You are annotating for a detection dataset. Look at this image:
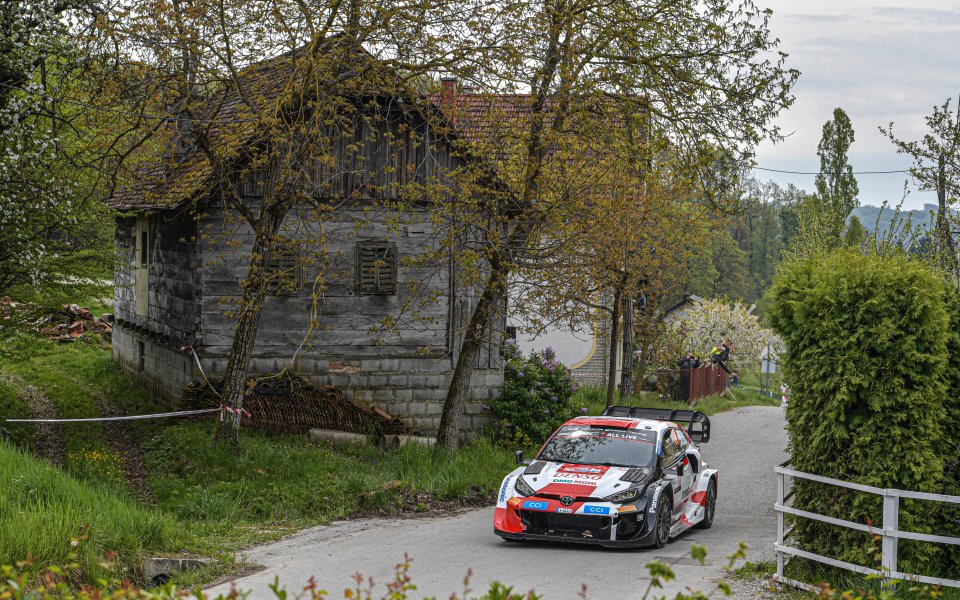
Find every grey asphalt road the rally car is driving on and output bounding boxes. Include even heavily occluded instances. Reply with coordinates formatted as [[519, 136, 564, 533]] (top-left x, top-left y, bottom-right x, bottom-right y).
[[209, 406, 787, 600]]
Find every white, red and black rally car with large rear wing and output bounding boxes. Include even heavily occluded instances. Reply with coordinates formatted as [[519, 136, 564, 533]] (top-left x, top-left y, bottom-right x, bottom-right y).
[[493, 406, 717, 548]]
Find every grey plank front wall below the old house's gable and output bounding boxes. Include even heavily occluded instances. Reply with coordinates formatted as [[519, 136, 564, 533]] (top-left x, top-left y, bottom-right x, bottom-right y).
[[197, 207, 503, 432]]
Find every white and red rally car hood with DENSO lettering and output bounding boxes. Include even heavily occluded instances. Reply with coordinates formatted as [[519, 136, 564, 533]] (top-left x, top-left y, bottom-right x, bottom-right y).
[[523, 461, 653, 500]]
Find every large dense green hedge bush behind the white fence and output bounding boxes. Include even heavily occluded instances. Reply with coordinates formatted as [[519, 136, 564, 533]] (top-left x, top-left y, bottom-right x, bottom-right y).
[[769, 250, 950, 572]]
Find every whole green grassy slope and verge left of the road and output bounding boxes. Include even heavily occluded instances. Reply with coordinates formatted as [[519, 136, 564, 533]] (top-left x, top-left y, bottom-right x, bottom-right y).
[[0, 330, 514, 583]]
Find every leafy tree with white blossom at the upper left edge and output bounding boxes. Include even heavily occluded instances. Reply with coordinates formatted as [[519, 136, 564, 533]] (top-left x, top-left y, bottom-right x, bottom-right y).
[[0, 0, 109, 299]]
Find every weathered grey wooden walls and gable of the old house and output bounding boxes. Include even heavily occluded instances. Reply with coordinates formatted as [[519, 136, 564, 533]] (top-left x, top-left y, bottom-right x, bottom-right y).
[[114, 103, 503, 432]]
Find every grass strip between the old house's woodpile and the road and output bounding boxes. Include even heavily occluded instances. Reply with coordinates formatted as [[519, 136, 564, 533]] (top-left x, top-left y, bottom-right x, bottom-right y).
[[144, 424, 513, 526]]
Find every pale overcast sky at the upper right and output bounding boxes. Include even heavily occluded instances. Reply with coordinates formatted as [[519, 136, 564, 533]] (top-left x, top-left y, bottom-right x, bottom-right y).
[[754, 0, 960, 208]]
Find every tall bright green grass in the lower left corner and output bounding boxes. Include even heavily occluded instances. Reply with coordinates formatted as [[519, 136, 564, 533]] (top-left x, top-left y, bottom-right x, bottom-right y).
[[0, 442, 182, 581]]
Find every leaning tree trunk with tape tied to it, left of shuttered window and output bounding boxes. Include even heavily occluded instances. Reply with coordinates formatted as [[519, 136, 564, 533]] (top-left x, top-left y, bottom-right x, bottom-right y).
[[216, 211, 285, 448]]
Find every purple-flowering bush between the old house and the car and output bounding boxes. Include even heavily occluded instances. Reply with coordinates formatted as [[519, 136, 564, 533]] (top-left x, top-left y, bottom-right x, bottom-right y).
[[487, 346, 578, 446]]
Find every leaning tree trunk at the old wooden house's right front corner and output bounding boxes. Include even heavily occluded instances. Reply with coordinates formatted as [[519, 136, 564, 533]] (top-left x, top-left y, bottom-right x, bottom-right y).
[[437, 263, 509, 450]]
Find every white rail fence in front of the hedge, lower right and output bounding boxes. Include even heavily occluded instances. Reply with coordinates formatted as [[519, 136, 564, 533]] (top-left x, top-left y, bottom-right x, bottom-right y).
[[774, 463, 960, 591]]
